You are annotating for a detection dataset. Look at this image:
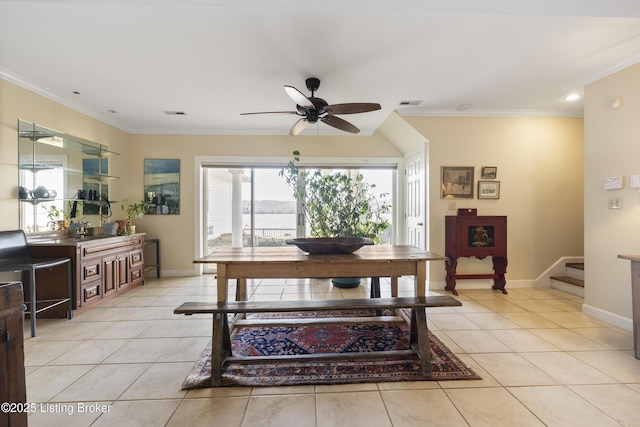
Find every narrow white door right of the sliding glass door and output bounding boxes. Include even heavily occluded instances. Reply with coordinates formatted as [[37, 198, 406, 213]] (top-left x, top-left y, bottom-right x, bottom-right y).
[[405, 151, 427, 249]]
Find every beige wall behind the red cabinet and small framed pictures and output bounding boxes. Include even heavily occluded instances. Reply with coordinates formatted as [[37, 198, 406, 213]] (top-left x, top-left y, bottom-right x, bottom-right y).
[[405, 117, 583, 287]]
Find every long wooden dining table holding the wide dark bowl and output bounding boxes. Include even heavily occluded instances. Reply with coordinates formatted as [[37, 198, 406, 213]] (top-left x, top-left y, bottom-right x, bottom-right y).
[[194, 245, 445, 302]]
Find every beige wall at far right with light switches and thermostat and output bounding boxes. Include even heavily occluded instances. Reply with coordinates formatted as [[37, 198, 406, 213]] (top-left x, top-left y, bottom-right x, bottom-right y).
[[584, 64, 640, 325]]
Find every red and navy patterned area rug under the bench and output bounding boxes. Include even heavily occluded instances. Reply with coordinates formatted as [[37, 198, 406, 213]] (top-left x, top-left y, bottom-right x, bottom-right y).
[[182, 313, 480, 390]]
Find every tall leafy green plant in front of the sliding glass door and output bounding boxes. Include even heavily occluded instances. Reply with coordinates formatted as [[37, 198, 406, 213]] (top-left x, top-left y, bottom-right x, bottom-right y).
[[280, 150, 390, 242]]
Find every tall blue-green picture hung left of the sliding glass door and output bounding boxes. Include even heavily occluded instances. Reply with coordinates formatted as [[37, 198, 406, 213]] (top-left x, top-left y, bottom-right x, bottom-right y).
[[144, 159, 180, 215]]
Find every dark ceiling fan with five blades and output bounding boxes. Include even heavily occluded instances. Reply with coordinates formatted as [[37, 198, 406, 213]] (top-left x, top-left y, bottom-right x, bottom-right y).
[[241, 77, 380, 136]]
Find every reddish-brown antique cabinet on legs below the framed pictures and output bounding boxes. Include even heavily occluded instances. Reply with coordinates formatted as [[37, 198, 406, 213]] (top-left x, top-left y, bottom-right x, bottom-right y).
[[445, 216, 507, 295]]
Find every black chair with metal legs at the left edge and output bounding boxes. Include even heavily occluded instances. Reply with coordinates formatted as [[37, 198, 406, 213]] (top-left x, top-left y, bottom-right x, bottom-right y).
[[0, 230, 73, 337]]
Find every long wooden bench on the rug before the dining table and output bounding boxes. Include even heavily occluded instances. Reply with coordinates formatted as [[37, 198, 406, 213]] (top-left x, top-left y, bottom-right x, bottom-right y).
[[174, 295, 462, 387]]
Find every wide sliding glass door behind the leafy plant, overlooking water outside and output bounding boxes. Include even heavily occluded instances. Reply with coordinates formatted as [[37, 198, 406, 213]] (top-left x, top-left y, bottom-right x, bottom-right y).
[[202, 165, 395, 260]]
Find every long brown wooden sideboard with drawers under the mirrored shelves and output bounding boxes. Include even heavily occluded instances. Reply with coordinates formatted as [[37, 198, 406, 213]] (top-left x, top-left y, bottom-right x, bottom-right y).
[[29, 234, 144, 310]]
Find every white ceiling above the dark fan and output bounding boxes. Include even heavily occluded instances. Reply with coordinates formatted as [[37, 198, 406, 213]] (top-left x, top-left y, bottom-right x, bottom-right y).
[[0, 0, 640, 135]]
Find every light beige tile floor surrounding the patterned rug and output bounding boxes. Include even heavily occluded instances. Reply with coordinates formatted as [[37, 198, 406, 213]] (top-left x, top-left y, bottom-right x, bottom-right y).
[[25, 276, 640, 427]]
